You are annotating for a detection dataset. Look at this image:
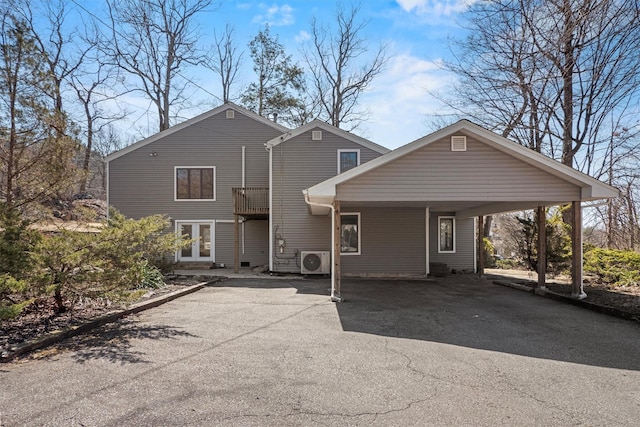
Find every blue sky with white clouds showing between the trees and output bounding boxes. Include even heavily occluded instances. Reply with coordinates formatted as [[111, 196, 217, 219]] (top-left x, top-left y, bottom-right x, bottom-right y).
[[69, 0, 474, 148]]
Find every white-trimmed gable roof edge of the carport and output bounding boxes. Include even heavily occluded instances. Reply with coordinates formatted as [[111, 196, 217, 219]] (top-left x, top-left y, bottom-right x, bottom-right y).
[[303, 120, 619, 211]]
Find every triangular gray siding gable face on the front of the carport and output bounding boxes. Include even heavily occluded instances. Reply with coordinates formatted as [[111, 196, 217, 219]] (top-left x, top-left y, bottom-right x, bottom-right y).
[[337, 136, 580, 202]]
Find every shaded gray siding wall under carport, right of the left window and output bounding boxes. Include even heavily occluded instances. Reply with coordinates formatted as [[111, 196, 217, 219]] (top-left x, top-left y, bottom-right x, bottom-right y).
[[340, 207, 426, 274]]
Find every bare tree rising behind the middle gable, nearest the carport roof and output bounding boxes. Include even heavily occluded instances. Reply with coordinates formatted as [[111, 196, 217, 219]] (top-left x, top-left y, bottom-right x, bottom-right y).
[[303, 2, 387, 130]]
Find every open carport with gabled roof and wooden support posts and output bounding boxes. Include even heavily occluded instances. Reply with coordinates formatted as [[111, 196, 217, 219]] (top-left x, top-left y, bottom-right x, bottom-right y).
[[303, 120, 619, 301]]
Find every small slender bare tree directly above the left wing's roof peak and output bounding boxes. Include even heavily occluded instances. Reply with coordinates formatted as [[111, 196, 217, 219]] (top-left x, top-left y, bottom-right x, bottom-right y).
[[205, 25, 242, 103]]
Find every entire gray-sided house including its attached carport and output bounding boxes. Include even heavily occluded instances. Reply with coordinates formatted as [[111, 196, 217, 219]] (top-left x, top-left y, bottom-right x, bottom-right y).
[[107, 103, 618, 298]]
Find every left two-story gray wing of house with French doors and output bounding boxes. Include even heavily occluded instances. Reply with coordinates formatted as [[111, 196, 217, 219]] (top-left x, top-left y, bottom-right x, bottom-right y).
[[107, 104, 288, 266]]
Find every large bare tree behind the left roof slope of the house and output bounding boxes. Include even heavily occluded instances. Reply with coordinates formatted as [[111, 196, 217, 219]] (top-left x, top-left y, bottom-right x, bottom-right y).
[[102, 0, 212, 131]]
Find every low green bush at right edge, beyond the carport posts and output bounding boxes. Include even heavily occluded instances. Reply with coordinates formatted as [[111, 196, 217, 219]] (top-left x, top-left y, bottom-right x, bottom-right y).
[[584, 248, 640, 286]]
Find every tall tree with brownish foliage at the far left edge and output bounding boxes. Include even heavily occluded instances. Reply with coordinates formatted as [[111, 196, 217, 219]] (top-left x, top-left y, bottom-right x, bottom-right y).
[[0, 9, 77, 207]]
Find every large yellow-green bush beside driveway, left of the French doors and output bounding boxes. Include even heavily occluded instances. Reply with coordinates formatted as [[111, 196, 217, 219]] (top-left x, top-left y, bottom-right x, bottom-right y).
[[35, 210, 190, 312]]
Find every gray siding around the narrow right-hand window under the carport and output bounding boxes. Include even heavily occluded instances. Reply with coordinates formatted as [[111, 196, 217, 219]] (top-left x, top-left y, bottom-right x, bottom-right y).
[[429, 212, 476, 271]]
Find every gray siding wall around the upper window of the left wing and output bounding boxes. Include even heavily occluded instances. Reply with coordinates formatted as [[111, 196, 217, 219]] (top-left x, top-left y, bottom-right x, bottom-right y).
[[109, 111, 281, 220]]
